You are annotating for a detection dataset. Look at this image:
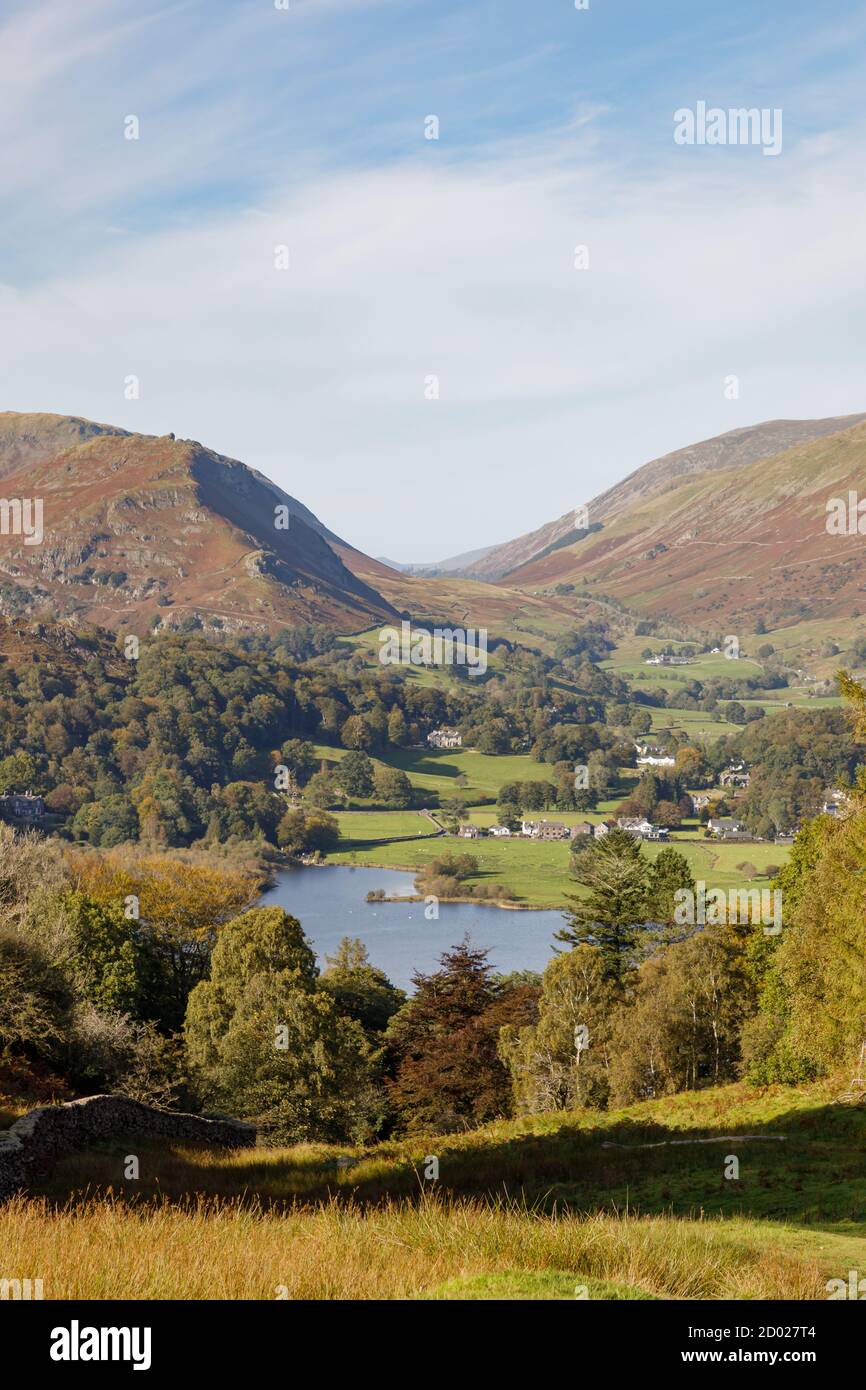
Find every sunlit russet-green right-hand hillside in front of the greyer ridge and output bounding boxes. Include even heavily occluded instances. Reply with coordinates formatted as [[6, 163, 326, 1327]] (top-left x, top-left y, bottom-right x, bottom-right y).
[[505, 416, 866, 632]]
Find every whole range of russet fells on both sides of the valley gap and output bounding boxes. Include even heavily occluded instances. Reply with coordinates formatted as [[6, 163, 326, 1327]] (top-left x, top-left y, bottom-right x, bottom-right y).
[[0, 413, 866, 648]]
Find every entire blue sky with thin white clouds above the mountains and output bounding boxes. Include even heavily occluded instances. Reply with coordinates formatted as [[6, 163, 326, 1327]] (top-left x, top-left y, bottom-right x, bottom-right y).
[[0, 0, 866, 560]]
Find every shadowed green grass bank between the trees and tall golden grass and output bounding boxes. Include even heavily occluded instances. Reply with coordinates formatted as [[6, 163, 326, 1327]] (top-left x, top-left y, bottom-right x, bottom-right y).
[[27, 1080, 866, 1226]]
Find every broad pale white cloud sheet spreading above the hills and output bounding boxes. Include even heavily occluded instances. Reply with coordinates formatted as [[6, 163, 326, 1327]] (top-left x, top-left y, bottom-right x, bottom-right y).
[[0, 0, 866, 560]]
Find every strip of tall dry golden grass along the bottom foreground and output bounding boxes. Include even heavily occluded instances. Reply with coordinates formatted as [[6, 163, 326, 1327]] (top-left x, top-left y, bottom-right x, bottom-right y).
[[0, 1195, 826, 1300]]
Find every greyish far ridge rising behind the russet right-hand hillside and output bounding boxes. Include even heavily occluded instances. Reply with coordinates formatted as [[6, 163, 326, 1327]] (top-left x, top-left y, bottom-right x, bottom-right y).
[[460, 414, 866, 581]]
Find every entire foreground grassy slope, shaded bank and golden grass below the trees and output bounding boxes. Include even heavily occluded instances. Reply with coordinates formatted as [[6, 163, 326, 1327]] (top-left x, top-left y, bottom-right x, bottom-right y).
[[8, 1077, 866, 1300]]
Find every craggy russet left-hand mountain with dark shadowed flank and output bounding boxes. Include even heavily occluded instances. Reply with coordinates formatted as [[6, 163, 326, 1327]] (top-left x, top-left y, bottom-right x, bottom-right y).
[[0, 413, 396, 632]]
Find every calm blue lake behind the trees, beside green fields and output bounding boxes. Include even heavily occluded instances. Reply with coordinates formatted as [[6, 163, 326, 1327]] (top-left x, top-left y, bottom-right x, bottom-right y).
[[261, 865, 563, 990]]
